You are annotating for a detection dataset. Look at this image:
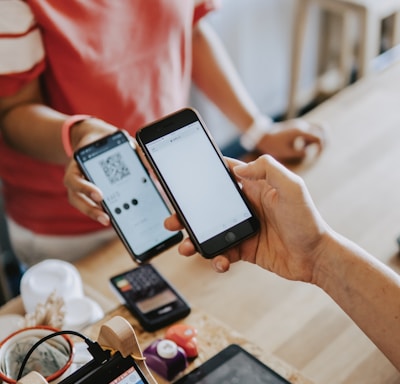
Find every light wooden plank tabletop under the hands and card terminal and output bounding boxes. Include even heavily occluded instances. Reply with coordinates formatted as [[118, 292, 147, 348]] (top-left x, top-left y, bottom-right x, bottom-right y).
[[2, 64, 400, 384]]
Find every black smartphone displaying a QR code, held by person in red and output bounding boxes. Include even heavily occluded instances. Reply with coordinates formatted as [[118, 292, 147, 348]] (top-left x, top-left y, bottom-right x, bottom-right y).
[[74, 131, 183, 263]]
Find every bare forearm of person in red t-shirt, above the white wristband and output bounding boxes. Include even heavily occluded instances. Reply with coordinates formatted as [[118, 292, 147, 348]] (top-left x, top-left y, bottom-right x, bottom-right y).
[[192, 21, 260, 130]]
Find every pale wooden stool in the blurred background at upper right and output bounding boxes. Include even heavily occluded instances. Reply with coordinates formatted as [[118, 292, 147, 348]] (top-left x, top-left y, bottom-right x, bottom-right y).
[[287, 0, 400, 118]]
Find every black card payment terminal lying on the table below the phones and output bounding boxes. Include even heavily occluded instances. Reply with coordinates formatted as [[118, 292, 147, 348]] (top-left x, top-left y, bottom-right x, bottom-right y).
[[110, 264, 190, 332]]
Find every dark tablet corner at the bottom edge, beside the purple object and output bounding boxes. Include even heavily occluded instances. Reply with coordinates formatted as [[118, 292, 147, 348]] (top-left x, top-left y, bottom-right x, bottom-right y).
[[175, 344, 290, 384]]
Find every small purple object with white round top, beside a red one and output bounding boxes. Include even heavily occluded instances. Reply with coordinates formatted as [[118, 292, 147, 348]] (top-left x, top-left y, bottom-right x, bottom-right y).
[[143, 339, 188, 381]]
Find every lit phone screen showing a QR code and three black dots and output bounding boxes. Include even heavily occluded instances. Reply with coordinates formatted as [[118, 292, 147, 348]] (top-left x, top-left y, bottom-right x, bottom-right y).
[[83, 138, 173, 255]]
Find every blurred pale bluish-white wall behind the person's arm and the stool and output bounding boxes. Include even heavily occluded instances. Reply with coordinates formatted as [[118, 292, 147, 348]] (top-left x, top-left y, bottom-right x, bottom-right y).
[[192, 0, 318, 147]]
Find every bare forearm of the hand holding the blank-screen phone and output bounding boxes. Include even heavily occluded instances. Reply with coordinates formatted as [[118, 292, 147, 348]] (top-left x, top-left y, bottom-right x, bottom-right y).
[[314, 234, 400, 369]]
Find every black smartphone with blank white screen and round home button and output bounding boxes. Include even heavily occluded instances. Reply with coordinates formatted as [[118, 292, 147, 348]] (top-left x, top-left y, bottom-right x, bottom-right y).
[[136, 108, 259, 258]]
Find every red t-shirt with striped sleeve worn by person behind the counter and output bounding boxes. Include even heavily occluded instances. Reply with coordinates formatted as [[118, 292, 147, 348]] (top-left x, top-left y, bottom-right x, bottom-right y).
[[0, 0, 219, 235]]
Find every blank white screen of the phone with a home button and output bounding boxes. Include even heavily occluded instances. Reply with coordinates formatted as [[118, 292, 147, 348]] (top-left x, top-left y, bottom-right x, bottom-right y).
[[146, 122, 252, 243]]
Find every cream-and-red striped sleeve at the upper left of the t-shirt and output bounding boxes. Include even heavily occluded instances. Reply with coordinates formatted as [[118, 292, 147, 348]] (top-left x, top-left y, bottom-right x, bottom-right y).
[[0, 0, 45, 97]]
